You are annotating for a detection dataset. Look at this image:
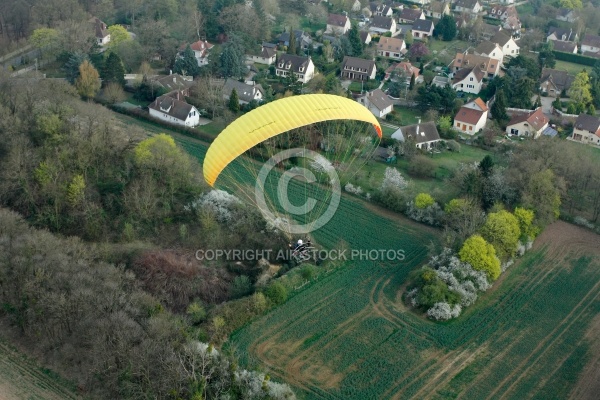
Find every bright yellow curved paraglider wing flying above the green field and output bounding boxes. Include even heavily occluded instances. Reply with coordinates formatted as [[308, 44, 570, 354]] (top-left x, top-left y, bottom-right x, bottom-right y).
[[203, 94, 381, 186]]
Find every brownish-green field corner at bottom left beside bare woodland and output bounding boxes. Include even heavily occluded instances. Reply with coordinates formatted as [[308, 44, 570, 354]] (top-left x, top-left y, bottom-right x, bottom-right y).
[[0, 338, 79, 400]]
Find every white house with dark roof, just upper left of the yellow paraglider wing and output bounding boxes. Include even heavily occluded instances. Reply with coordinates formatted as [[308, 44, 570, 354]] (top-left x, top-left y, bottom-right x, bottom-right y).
[[148, 91, 200, 127]]
